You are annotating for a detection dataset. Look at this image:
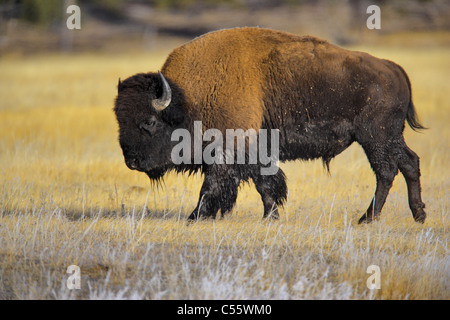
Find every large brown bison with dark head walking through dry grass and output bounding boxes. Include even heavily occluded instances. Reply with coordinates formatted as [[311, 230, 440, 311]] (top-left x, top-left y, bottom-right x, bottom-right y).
[[114, 28, 426, 223]]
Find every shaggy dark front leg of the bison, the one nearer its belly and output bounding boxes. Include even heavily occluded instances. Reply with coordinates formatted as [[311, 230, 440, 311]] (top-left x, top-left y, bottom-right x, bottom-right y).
[[251, 167, 287, 219]]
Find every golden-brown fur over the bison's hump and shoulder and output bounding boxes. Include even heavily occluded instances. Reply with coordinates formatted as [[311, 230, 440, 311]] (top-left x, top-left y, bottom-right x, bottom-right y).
[[162, 28, 320, 130]]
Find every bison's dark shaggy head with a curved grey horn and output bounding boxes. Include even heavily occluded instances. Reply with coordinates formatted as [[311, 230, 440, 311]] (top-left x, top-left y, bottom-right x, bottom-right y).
[[114, 72, 184, 179]]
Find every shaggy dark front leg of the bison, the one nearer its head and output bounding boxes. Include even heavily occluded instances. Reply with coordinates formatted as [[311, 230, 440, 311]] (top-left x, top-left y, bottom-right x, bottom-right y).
[[188, 165, 240, 220]]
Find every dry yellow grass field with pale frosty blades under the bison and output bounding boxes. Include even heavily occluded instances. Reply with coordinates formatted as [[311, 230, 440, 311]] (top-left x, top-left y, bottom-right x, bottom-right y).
[[0, 41, 450, 299]]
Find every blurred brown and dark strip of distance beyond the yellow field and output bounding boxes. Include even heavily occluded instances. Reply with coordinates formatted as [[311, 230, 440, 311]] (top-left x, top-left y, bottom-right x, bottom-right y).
[[0, 0, 450, 54]]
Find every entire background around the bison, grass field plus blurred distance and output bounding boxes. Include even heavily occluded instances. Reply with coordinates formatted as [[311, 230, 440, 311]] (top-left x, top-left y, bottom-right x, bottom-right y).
[[0, 0, 450, 300]]
